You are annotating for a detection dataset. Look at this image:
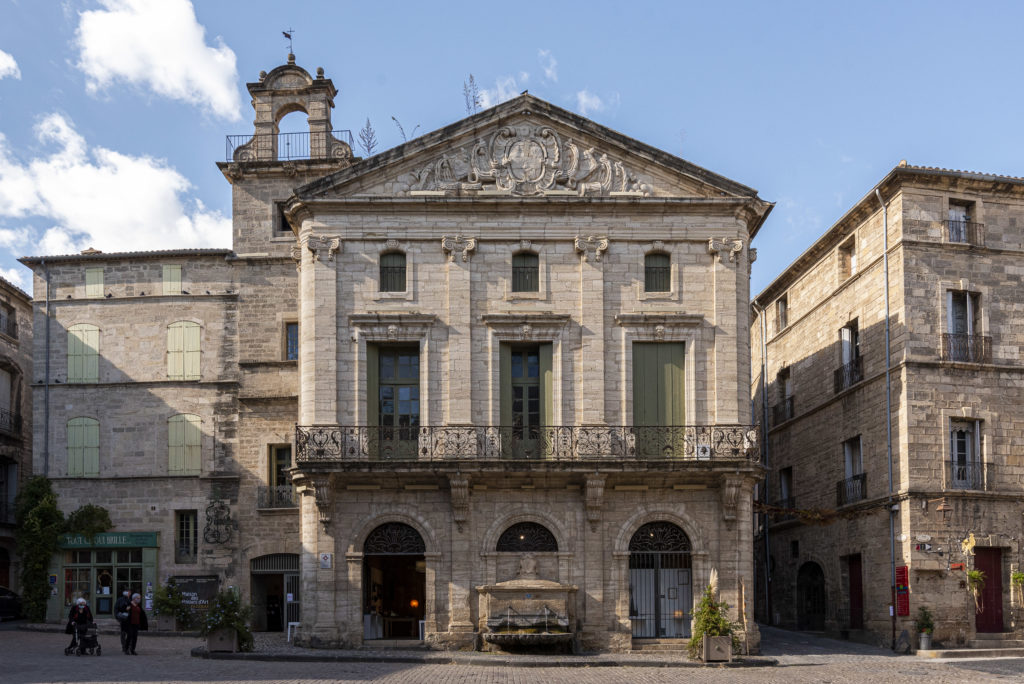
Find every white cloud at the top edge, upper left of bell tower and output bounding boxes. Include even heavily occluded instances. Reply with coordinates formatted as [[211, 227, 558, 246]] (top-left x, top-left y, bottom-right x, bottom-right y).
[[77, 0, 242, 121]]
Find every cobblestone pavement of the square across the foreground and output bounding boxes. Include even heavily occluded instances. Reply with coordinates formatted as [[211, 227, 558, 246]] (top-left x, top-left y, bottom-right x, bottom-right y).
[[6, 628, 1024, 684]]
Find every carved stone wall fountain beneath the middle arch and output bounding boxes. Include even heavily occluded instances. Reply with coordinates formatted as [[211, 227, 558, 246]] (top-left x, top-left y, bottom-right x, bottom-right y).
[[476, 554, 578, 651]]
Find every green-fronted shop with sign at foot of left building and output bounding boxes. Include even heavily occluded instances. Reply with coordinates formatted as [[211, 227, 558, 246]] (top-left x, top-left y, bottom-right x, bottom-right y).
[[46, 532, 160, 621]]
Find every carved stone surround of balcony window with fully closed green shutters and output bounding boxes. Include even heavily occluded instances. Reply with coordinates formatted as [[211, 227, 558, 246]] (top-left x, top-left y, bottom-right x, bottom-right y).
[[614, 312, 715, 425]]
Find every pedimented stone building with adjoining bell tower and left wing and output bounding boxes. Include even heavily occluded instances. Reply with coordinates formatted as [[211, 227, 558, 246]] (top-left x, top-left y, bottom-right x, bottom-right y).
[[25, 60, 771, 650]]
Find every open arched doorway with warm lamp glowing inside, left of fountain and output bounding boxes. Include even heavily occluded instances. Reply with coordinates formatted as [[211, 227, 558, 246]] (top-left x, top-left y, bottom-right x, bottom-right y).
[[362, 522, 427, 639]]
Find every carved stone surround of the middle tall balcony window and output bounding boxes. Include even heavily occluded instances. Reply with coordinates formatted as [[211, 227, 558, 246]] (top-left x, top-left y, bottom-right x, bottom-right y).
[[481, 313, 571, 425]]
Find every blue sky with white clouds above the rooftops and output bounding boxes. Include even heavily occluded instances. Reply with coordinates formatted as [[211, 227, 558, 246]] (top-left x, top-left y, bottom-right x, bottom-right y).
[[0, 0, 1024, 293]]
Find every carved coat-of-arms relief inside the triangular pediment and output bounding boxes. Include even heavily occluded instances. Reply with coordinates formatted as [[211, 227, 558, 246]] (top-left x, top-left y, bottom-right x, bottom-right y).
[[399, 124, 653, 197]]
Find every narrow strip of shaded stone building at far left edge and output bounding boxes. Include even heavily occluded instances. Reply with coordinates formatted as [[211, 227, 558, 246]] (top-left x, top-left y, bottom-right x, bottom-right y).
[[0, 279, 32, 591]]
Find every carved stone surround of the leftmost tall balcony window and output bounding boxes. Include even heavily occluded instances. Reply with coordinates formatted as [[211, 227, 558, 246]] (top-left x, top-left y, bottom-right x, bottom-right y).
[[348, 313, 441, 425]]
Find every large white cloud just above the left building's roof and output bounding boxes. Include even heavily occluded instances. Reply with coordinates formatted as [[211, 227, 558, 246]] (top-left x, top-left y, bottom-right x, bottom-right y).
[[0, 114, 231, 254]]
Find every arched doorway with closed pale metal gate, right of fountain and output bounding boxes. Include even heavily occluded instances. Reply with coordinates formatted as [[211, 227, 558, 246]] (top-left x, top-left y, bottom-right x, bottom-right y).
[[630, 521, 693, 639]]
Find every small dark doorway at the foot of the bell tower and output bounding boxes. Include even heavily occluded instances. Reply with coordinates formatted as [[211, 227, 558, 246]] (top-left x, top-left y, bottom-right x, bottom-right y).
[[249, 553, 299, 632]]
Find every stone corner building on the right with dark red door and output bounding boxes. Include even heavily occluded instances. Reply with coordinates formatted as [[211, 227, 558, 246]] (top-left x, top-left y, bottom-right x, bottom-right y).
[[751, 163, 1024, 647]]
